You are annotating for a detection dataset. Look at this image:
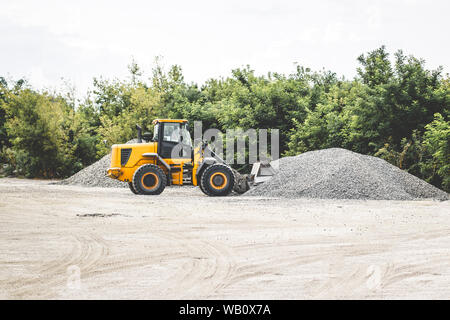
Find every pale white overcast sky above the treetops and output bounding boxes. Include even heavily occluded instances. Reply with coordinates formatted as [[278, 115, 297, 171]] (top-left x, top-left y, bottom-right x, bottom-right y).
[[0, 0, 450, 94]]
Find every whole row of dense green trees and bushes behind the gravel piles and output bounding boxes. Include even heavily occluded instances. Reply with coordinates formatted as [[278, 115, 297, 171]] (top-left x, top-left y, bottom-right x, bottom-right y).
[[0, 47, 450, 191]]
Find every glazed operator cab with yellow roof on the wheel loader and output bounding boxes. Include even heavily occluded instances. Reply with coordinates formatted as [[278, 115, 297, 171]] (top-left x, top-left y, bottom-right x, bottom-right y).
[[153, 119, 192, 159]]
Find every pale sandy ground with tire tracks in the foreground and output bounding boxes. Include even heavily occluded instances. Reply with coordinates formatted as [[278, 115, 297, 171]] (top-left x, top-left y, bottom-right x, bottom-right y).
[[0, 179, 450, 299]]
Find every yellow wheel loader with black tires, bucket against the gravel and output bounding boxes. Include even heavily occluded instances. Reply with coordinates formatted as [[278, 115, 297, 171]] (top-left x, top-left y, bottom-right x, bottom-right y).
[[107, 119, 256, 196]]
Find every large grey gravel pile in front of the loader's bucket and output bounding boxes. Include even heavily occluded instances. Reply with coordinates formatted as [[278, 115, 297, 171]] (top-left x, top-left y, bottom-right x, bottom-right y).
[[245, 148, 449, 200]]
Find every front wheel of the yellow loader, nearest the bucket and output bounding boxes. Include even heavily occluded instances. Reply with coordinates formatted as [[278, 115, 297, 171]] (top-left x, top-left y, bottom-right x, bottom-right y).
[[200, 163, 235, 197]]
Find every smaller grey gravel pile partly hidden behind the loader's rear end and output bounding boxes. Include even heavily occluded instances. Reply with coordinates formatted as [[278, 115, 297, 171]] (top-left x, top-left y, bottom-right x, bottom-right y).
[[59, 139, 137, 188]]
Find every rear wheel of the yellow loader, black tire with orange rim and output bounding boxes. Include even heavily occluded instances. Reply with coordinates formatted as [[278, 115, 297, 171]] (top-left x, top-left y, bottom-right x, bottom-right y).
[[133, 164, 167, 195]]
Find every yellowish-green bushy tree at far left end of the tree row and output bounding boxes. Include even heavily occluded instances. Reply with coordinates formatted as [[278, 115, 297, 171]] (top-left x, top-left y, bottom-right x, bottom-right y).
[[3, 88, 76, 178]]
